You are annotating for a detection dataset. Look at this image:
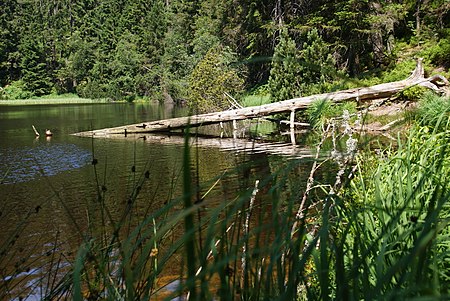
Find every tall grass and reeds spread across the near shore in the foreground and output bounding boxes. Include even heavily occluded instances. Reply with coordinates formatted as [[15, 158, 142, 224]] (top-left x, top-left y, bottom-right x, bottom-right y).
[[3, 93, 450, 300]]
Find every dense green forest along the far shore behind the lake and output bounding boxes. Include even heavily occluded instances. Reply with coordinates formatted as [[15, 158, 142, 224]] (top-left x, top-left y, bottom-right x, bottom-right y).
[[0, 0, 450, 111]]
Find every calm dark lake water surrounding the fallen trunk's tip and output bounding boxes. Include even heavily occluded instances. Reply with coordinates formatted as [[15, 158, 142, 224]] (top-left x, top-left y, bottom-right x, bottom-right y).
[[0, 103, 332, 300]]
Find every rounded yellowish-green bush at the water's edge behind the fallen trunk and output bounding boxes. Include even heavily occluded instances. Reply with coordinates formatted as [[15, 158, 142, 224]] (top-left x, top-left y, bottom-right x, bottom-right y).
[[188, 47, 244, 112]]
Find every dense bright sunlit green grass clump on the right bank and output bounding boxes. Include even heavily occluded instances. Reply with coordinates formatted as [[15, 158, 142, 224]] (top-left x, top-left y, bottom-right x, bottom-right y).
[[342, 123, 450, 299]]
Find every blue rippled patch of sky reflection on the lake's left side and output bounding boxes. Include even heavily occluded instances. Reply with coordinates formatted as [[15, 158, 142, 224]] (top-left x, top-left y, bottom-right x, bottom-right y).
[[0, 144, 92, 184]]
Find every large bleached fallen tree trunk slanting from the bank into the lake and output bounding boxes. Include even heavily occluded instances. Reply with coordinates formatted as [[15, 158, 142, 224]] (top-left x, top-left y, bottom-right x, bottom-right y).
[[75, 59, 449, 136]]
